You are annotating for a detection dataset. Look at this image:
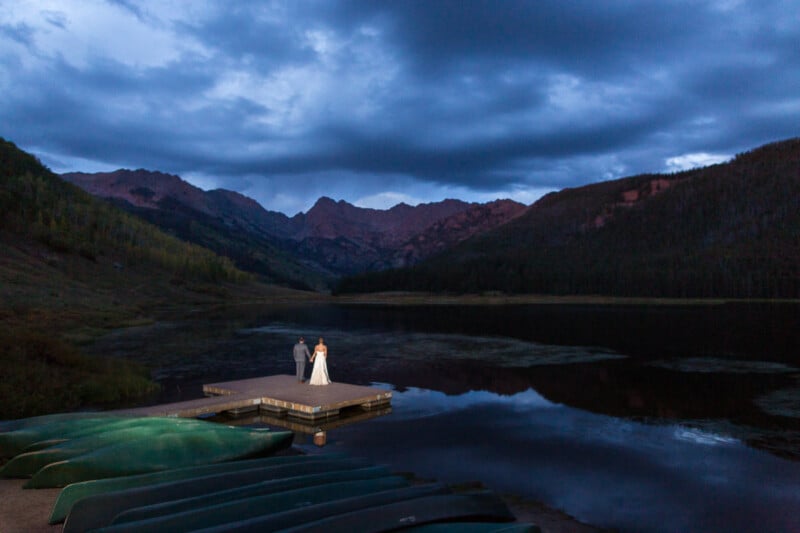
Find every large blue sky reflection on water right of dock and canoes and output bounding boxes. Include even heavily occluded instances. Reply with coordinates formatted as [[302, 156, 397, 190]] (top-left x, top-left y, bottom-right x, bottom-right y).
[[328, 388, 800, 532]]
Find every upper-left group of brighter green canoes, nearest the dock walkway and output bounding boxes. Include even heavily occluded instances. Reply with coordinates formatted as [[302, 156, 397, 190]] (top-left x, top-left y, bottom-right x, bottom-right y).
[[0, 416, 293, 488]]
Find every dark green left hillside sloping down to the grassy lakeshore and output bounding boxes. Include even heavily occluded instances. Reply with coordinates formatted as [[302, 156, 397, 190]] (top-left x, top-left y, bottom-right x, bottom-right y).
[[0, 139, 252, 419]]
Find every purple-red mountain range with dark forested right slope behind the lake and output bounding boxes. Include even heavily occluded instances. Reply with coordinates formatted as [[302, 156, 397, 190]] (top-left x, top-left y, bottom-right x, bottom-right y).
[[4, 133, 800, 299]]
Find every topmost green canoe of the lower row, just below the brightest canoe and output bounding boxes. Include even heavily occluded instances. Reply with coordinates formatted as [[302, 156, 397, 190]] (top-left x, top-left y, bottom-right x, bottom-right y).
[[49, 454, 342, 524]]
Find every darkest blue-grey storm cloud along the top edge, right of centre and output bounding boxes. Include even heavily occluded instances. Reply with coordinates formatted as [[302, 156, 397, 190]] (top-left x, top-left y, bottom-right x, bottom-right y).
[[332, 0, 714, 77]]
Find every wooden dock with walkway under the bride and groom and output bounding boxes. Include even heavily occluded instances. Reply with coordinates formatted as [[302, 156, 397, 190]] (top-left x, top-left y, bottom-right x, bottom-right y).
[[120, 375, 392, 420]]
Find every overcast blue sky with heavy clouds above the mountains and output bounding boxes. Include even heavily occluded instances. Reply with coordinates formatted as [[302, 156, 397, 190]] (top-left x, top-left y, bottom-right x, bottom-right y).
[[0, 0, 800, 215]]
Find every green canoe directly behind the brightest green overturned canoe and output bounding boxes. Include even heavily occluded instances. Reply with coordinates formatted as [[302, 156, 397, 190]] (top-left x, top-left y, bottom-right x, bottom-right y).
[[0, 419, 219, 477]]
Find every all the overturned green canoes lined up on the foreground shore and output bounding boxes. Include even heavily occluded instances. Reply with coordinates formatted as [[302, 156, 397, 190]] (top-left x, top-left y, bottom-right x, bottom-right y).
[[0, 416, 539, 533]]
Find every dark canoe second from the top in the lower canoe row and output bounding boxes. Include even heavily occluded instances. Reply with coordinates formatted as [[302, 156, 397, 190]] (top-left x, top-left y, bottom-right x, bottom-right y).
[[63, 458, 366, 533]]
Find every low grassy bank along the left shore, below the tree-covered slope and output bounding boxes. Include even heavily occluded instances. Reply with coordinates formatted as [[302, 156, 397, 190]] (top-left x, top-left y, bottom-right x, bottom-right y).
[[0, 244, 310, 420]]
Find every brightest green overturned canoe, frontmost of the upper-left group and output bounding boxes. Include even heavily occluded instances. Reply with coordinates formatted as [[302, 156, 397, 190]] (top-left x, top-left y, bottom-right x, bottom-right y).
[[24, 424, 294, 488]]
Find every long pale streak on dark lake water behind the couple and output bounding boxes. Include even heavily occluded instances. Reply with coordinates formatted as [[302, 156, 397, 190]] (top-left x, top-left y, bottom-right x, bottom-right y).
[[241, 322, 625, 367]]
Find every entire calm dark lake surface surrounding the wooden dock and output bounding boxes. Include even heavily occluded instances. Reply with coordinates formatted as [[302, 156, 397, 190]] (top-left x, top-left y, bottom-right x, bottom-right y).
[[92, 305, 800, 531]]
